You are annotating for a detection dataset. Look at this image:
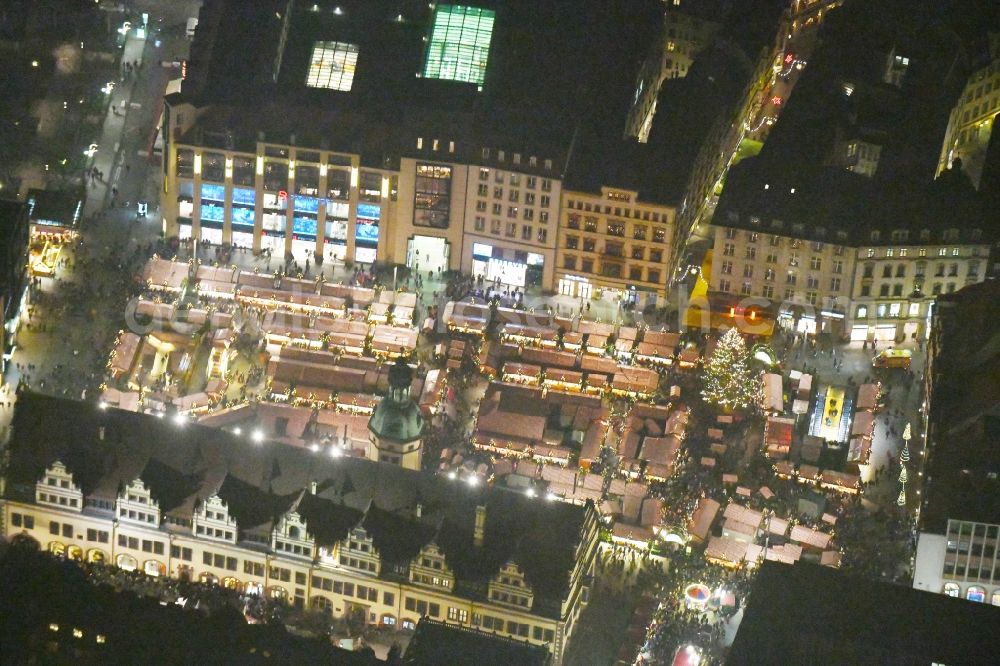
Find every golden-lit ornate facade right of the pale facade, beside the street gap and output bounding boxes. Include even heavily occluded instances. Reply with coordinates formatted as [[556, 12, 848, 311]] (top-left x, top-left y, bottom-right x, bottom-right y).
[[556, 187, 676, 307]]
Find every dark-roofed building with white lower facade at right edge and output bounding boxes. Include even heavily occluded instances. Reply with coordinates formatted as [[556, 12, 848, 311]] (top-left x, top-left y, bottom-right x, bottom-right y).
[[911, 280, 1000, 606]]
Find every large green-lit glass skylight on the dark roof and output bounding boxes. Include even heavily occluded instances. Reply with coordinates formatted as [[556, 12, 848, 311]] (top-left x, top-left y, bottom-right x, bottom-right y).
[[424, 5, 496, 86]]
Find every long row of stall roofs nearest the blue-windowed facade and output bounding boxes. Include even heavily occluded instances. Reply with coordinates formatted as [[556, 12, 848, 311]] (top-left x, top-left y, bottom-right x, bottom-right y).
[[142, 257, 417, 326]]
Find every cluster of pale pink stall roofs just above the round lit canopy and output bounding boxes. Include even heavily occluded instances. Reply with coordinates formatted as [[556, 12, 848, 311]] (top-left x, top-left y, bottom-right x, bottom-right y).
[[688, 496, 840, 568]]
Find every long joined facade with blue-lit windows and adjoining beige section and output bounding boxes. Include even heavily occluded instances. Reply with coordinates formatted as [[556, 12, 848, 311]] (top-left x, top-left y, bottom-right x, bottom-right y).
[[163, 104, 562, 290]]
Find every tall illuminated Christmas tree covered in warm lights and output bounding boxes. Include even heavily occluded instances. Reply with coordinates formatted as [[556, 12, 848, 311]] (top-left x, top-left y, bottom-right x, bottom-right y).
[[702, 328, 762, 411]]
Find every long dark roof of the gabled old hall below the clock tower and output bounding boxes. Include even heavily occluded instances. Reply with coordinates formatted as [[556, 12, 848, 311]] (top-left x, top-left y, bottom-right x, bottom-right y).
[[7, 393, 592, 615]]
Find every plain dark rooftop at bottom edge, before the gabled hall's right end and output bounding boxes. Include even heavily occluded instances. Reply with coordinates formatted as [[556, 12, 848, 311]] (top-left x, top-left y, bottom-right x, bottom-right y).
[[402, 617, 552, 666]]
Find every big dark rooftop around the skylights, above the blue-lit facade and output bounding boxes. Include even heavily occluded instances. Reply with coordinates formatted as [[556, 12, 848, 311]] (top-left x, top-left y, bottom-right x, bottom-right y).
[[176, 0, 661, 158]]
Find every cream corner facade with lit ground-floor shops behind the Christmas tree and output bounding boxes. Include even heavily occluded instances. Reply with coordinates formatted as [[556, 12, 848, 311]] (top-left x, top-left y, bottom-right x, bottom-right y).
[[708, 216, 991, 343]]
